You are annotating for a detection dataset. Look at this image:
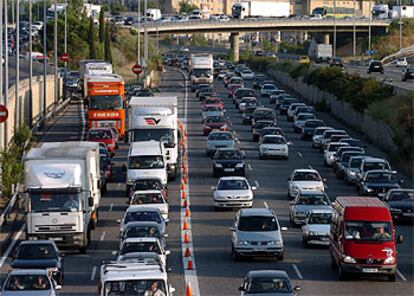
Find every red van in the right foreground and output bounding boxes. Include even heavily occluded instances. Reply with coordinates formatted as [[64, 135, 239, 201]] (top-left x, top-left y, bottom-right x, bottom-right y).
[[329, 196, 402, 281]]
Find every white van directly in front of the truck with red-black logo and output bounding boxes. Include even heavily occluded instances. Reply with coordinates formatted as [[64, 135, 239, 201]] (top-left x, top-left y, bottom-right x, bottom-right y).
[[127, 141, 167, 193]]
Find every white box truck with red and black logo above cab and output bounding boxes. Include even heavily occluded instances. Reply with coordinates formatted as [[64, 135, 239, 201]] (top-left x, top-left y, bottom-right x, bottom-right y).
[[128, 97, 179, 179]]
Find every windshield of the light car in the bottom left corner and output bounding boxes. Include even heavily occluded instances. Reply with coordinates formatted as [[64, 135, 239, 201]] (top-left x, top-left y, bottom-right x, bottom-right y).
[[4, 275, 50, 295]]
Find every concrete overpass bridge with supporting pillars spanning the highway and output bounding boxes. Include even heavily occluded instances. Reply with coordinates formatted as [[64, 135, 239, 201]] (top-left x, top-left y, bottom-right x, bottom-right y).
[[140, 18, 390, 61]]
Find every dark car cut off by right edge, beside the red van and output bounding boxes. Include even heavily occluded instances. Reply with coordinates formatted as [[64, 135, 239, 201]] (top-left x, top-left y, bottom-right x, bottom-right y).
[[383, 188, 414, 221]]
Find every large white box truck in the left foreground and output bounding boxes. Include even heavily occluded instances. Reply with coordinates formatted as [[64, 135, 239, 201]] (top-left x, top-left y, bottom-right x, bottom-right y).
[[24, 143, 100, 253]]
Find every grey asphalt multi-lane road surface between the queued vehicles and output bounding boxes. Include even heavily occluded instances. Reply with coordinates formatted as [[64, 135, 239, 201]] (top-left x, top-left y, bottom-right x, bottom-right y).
[[1, 70, 414, 296]]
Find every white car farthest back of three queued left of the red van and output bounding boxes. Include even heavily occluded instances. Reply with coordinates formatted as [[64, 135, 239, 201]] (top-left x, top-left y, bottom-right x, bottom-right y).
[[288, 169, 325, 199]]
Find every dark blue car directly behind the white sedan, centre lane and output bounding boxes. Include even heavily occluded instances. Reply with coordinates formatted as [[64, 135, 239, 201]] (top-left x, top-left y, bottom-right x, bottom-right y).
[[213, 148, 246, 178]]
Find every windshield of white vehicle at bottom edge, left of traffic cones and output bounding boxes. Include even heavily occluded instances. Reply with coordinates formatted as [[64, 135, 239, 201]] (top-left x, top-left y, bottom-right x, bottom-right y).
[[103, 279, 166, 296]]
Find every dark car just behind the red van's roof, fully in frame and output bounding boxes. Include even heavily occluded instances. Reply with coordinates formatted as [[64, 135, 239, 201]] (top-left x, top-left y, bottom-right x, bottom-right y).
[[357, 170, 403, 198]]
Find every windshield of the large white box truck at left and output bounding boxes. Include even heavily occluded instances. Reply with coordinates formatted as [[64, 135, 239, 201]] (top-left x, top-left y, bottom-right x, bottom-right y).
[[30, 192, 80, 213]]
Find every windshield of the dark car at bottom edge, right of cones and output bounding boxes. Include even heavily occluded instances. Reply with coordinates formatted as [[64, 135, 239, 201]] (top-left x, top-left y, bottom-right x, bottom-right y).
[[247, 277, 292, 295]]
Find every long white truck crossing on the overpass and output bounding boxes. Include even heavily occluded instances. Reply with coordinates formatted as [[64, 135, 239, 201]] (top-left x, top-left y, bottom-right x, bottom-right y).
[[232, 1, 290, 19]]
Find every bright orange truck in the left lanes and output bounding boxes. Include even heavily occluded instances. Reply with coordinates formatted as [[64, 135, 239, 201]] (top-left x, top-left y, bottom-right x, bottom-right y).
[[85, 74, 125, 138]]
